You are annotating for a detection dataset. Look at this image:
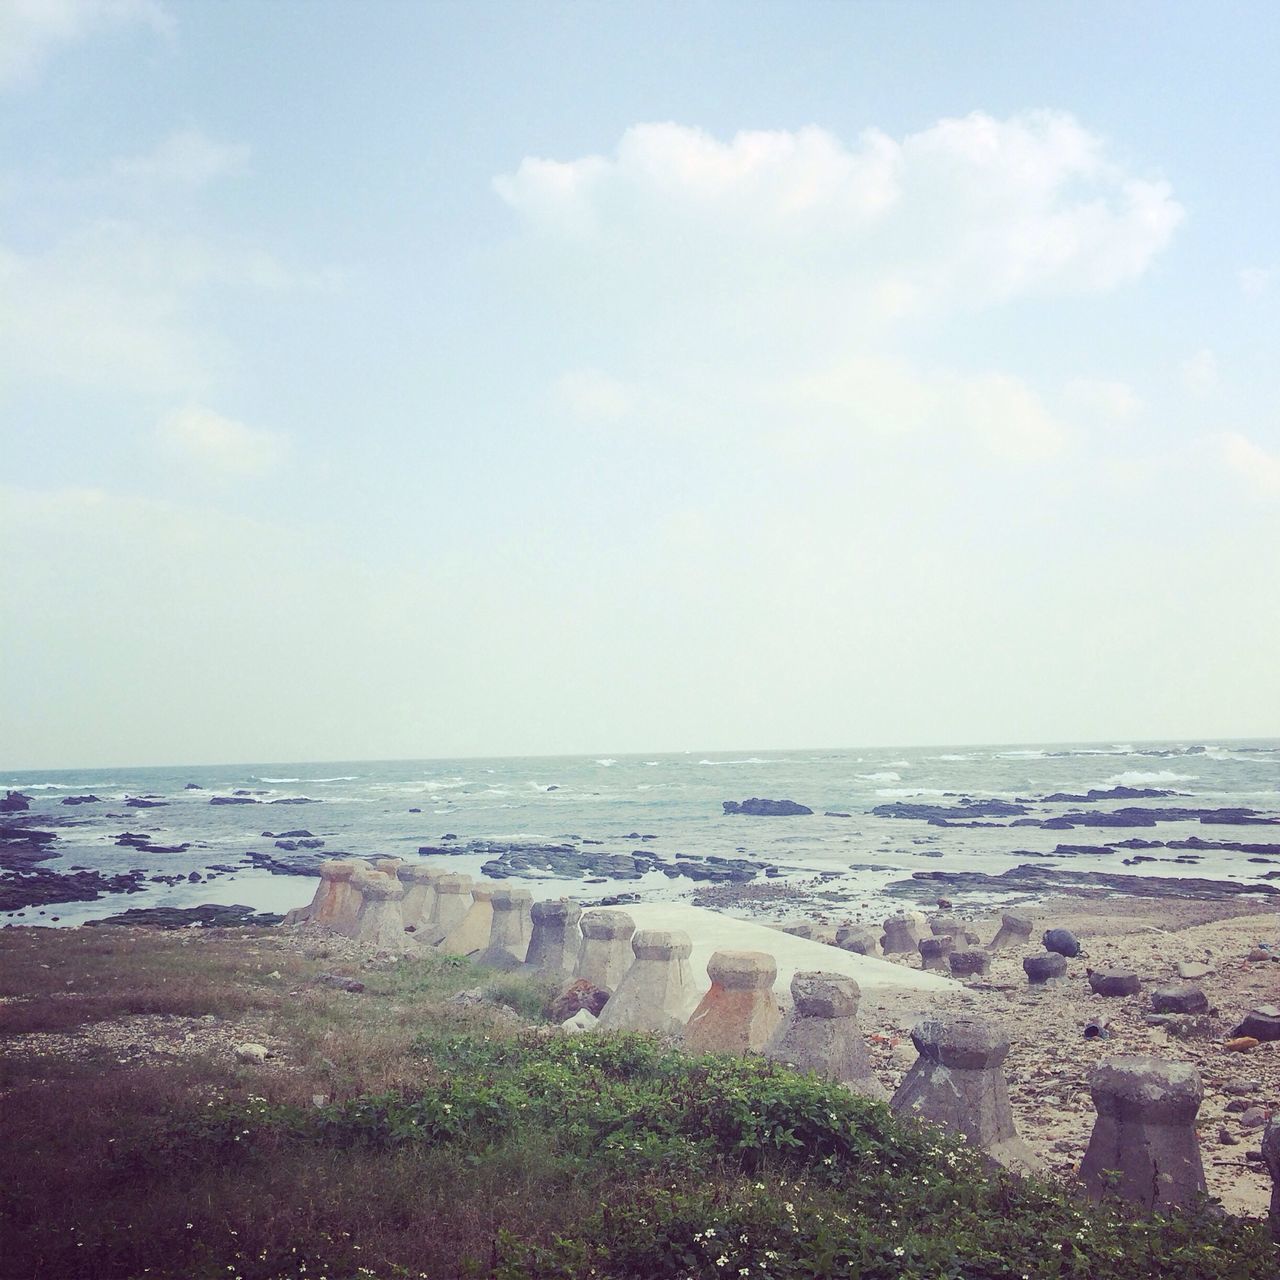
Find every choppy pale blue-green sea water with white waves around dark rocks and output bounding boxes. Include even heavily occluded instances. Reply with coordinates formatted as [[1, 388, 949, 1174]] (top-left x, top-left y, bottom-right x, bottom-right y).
[[0, 740, 1280, 924]]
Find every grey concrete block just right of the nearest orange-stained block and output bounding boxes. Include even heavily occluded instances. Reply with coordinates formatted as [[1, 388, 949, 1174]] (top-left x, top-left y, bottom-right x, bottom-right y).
[[764, 967, 890, 1102]]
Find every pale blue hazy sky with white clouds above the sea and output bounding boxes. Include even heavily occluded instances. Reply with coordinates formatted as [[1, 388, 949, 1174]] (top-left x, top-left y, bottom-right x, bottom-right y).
[[0, 0, 1280, 768]]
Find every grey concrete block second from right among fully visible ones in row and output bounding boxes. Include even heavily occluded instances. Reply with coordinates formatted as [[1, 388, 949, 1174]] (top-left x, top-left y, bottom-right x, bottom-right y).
[[890, 1014, 1039, 1172]]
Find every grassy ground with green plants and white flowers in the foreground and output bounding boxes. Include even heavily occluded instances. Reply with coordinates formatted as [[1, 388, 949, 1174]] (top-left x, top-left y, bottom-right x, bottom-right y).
[[0, 931, 1276, 1280]]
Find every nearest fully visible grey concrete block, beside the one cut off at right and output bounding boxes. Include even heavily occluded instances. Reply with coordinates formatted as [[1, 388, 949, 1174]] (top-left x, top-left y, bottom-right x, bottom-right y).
[[1080, 1053, 1204, 1210]]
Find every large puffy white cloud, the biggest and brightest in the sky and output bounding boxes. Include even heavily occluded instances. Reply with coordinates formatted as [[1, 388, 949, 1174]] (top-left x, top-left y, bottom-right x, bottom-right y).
[[494, 111, 1183, 315]]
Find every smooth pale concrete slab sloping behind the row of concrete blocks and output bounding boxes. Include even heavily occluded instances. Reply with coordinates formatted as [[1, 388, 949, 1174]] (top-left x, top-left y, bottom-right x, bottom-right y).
[[623, 902, 965, 998]]
